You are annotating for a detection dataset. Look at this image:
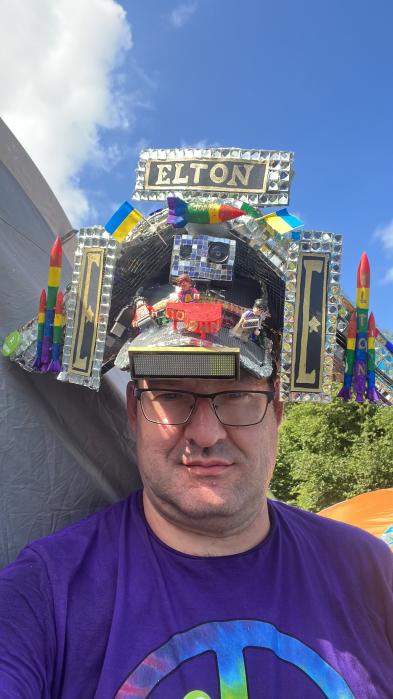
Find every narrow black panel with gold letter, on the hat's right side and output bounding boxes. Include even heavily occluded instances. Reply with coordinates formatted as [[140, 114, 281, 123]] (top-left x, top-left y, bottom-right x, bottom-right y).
[[291, 252, 330, 393]]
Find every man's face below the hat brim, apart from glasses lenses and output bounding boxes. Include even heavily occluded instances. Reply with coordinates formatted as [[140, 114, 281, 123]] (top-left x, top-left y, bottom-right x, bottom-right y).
[[128, 377, 281, 532]]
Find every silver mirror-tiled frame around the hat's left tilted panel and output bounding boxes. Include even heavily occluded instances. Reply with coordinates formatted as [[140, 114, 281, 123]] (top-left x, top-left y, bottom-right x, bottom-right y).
[[57, 227, 119, 391]]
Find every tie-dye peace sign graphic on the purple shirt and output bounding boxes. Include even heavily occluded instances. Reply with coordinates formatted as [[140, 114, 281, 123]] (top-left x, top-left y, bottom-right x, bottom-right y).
[[116, 619, 354, 699]]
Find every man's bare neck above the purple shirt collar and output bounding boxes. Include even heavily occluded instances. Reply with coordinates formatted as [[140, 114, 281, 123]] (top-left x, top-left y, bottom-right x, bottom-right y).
[[143, 492, 270, 557]]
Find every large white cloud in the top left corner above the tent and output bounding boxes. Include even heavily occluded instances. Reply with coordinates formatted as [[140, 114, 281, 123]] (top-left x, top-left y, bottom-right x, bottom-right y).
[[0, 0, 132, 225]]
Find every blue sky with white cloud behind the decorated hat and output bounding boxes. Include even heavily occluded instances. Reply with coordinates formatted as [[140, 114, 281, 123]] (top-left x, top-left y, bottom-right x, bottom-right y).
[[0, 0, 393, 330]]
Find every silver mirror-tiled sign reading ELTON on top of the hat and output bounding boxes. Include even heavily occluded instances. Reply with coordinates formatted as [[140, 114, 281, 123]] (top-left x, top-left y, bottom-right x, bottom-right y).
[[132, 148, 293, 207]]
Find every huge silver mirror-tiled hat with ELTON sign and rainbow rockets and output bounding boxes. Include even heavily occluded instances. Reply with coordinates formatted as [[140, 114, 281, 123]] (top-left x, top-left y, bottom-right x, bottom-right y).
[[3, 148, 393, 404]]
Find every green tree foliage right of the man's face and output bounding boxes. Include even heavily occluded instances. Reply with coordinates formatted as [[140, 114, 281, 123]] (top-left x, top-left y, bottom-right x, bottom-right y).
[[271, 389, 393, 512]]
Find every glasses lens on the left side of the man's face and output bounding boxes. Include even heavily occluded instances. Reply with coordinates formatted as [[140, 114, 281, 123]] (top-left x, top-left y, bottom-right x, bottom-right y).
[[141, 391, 195, 425]]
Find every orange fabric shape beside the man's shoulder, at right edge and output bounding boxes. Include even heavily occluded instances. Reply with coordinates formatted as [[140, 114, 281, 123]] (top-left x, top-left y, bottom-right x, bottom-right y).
[[319, 488, 393, 551]]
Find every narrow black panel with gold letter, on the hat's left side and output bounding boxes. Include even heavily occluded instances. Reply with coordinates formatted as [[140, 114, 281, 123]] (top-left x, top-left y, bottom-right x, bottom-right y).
[[69, 248, 104, 376]]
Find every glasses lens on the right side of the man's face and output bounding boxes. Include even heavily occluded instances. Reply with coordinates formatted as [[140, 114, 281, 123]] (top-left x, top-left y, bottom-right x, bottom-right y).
[[214, 391, 268, 427]]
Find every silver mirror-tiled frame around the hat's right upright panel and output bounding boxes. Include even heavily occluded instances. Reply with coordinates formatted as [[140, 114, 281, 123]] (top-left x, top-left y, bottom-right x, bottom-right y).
[[280, 231, 342, 403]]
